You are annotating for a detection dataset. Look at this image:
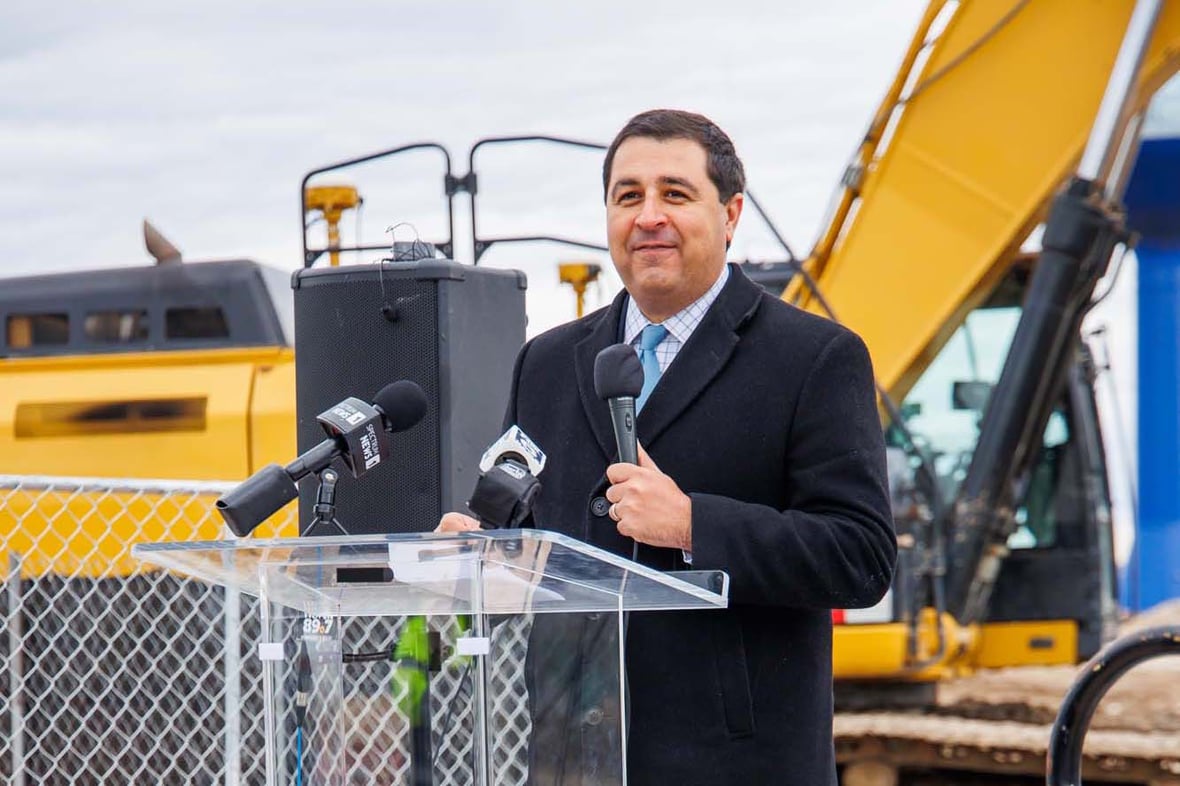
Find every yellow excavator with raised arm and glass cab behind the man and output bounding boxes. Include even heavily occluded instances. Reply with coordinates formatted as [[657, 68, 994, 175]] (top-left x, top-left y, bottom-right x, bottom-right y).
[[784, 0, 1180, 693]]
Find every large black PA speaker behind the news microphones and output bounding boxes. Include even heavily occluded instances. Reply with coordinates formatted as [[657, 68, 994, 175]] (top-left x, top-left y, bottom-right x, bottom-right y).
[[291, 260, 526, 535]]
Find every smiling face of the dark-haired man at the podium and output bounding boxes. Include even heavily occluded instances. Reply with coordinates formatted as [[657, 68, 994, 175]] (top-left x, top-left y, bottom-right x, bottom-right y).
[[607, 137, 742, 322]]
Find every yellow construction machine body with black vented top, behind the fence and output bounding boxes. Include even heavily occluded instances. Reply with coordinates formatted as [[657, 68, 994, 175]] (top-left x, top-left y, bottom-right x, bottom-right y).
[[0, 225, 295, 577]]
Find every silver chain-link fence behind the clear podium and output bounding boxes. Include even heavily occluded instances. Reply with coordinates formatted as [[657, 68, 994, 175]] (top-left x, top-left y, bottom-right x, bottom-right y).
[[0, 476, 531, 786]]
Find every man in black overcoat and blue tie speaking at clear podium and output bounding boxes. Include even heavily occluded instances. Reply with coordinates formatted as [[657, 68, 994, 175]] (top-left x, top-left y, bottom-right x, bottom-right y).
[[440, 110, 897, 786]]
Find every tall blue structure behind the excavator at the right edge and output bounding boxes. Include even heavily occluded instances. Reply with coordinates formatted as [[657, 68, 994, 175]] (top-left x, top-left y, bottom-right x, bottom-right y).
[[1123, 138, 1180, 610]]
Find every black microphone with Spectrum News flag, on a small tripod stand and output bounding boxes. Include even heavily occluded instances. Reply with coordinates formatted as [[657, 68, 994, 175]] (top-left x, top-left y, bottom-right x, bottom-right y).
[[216, 380, 427, 537]]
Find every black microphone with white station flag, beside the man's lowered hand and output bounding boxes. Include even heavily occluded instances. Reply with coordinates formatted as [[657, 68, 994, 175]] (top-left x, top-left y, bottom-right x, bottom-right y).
[[467, 426, 545, 530]]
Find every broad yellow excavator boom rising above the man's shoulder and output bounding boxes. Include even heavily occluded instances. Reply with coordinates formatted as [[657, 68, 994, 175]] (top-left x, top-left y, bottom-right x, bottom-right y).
[[784, 0, 1180, 399]]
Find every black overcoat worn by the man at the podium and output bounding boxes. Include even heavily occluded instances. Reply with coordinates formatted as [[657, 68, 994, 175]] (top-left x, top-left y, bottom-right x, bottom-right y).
[[506, 266, 897, 786]]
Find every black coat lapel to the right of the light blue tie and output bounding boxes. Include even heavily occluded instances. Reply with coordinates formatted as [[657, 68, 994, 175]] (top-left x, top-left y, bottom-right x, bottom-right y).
[[641, 264, 762, 448]]
